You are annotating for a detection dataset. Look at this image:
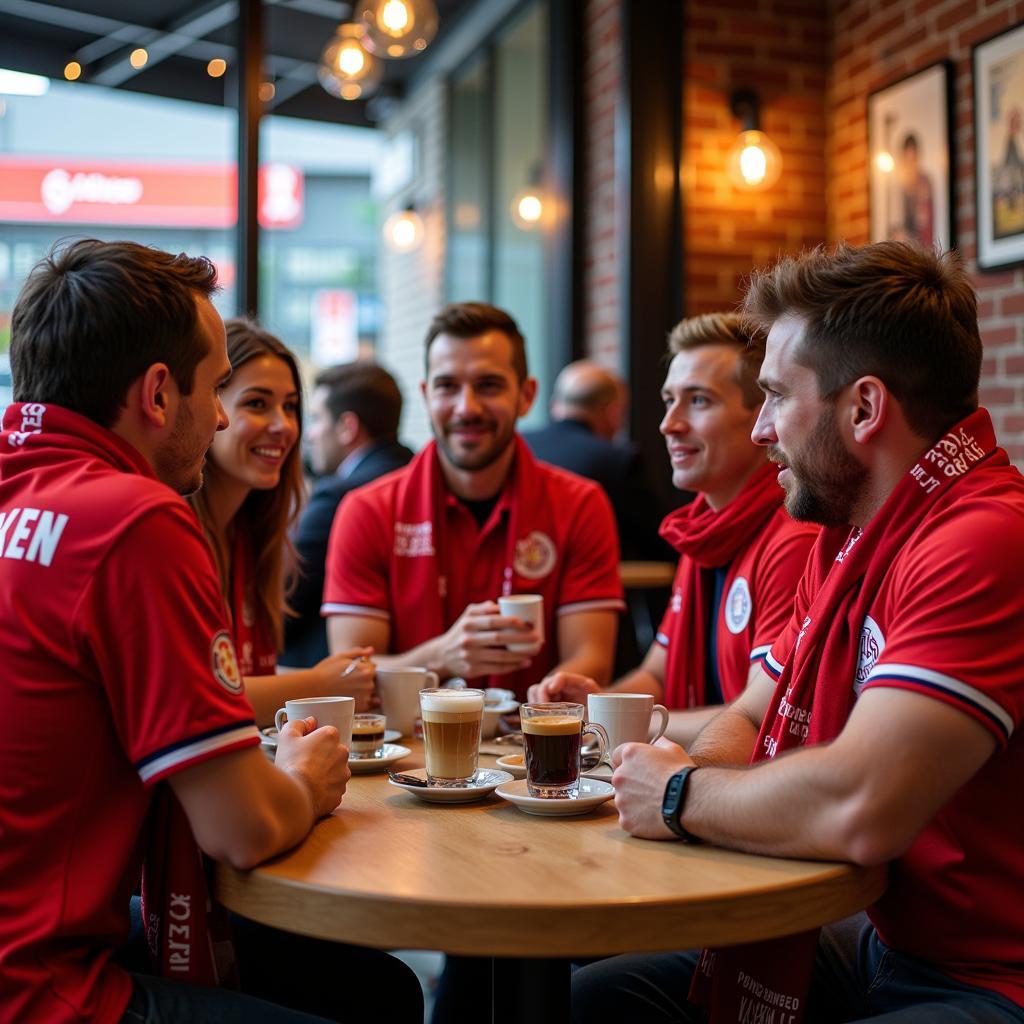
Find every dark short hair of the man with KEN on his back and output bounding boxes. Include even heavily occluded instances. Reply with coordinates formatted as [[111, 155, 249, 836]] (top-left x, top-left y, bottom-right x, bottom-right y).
[[10, 239, 217, 427]]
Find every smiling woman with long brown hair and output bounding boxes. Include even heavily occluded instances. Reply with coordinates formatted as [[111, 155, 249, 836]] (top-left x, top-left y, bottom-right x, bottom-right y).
[[188, 317, 374, 725]]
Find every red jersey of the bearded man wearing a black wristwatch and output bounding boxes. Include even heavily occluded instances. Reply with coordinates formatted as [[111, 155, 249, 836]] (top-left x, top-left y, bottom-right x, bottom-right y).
[[765, 466, 1024, 1006]]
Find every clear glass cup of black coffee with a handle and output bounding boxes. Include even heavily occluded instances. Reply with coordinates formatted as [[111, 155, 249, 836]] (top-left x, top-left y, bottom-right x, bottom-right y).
[[519, 701, 608, 800]]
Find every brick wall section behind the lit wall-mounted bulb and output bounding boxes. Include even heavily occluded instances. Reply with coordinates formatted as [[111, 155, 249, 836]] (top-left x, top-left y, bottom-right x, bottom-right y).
[[679, 0, 828, 315]]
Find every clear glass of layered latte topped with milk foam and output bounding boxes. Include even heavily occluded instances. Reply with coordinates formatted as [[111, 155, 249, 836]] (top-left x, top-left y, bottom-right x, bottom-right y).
[[420, 688, 483, 786]]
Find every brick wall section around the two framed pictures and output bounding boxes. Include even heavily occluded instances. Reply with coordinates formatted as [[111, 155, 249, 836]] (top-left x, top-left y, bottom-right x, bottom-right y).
[[827, 0, 1024, 465]]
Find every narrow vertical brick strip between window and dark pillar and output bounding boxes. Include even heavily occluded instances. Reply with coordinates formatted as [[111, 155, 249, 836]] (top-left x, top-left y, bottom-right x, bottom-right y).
[[581, 0, 622, 368]]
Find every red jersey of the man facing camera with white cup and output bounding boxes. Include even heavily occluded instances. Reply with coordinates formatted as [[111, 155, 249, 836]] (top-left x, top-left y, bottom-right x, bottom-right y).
[[322, 453, 625, 697]]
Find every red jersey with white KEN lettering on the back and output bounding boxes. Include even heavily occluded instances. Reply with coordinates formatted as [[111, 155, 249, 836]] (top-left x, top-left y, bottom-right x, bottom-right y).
[[0, 403, 259, 1024]]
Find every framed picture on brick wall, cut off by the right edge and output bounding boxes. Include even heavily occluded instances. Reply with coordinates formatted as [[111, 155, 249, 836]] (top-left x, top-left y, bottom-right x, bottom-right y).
[[971, 25, 1024, 270]]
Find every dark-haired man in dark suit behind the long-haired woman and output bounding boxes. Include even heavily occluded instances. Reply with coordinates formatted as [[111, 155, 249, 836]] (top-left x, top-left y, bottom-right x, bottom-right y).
[[281, 362, 413, 668]]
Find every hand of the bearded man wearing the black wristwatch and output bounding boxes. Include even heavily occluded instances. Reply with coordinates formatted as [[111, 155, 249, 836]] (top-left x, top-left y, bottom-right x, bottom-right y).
[[611, 738, 693, 839]]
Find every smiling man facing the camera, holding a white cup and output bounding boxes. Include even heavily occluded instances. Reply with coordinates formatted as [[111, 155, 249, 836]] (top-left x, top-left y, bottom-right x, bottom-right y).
[[322, 302, 624, 696]]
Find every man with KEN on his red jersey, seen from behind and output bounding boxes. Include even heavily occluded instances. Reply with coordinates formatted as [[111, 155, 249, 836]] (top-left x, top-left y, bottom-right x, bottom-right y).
[[0, 240, 416, 1024]]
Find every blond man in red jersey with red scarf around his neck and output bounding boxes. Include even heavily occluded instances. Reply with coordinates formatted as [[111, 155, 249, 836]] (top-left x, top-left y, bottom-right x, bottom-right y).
[[532, 313, 818, 744]]
